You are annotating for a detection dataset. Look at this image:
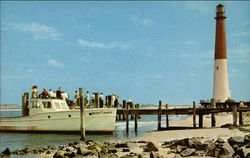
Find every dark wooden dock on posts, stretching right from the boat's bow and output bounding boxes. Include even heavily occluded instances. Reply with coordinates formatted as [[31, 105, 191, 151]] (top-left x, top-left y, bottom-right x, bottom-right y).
[[117, 100, 250, 133]]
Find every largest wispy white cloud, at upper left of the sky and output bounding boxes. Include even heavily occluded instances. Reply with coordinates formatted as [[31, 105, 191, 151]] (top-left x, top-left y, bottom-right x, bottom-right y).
[[7, 23, 61, 40]]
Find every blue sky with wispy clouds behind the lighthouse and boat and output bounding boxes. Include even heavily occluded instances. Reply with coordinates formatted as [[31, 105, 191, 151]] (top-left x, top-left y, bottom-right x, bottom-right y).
[[0, 1, 250, 105]]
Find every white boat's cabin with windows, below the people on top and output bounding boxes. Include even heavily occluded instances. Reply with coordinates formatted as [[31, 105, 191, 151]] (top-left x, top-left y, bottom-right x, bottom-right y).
[[28, 98, 69, 115]]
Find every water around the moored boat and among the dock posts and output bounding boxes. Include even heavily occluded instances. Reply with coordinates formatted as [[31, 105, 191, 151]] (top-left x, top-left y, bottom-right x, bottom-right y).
[[0, 108, 185, 151]]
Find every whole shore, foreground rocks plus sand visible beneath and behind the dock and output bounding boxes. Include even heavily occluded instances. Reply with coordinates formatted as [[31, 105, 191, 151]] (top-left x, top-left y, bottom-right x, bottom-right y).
[[0, 113, 250, 158]]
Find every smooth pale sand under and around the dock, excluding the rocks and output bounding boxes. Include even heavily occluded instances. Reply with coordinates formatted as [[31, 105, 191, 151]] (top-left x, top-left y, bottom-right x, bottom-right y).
[[136, 113, 250, 143]]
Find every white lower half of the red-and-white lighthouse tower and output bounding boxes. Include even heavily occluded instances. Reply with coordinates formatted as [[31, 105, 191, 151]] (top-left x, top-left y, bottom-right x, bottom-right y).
[[213, 59, 231, 102]]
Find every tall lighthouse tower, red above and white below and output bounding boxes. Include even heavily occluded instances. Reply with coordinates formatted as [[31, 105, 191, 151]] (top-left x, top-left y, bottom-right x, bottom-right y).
[[213, 4, 231, 102]]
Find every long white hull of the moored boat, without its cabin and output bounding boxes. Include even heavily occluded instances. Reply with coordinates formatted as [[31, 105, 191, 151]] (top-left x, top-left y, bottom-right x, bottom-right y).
[[0, 108, 116, 133]]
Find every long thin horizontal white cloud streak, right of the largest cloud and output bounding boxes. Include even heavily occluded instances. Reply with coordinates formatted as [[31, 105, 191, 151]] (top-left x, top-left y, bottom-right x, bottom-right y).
[[77, 39, 131, 49]]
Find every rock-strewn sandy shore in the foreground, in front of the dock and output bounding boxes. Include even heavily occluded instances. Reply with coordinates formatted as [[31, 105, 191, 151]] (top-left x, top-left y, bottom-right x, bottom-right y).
[[0, 128, 250, 158]]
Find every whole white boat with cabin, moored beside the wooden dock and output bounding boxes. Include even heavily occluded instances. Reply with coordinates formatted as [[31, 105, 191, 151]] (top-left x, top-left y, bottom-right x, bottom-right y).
[[0, 98, 116, 132]]
